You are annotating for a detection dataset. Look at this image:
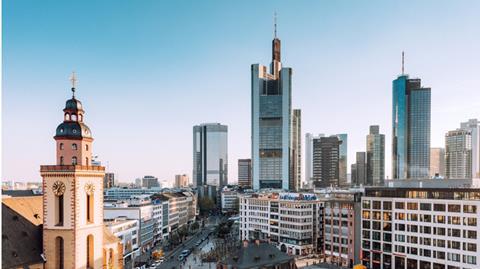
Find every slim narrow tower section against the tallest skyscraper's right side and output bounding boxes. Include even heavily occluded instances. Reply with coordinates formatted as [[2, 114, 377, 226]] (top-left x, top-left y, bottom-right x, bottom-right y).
[[290, 109, 302, 191]]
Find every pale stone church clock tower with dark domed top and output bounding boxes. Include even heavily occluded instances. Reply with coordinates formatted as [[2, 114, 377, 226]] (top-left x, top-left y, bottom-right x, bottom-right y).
[[40, 74, 105, 269]]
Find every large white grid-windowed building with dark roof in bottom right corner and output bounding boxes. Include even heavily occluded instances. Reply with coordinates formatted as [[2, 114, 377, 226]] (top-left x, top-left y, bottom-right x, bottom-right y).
[[360, 187, 480, 269]]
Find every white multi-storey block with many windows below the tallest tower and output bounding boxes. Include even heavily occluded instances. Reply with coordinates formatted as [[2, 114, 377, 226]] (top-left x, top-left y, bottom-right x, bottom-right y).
[[239, 193, 323, 255]]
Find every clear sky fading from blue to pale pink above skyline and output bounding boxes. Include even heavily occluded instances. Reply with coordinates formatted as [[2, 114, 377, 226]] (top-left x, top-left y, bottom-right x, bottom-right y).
[[2, 0, 480, 185]]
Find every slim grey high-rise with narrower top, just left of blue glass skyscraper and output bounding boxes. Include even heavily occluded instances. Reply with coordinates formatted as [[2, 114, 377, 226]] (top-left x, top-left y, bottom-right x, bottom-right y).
[[366, 125, 385, 186]]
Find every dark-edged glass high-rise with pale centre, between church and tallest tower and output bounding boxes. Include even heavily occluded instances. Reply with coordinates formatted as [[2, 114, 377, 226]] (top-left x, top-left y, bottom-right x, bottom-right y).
[[193, 123, 228, 187]]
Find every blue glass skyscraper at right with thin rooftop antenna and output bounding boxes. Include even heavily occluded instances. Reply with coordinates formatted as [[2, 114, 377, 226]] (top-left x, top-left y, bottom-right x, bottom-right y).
[[392, 60, 431, 179]]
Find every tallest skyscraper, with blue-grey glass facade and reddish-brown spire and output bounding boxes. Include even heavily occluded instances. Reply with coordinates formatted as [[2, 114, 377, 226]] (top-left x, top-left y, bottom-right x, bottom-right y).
[[251, 22, 293, 190]]
